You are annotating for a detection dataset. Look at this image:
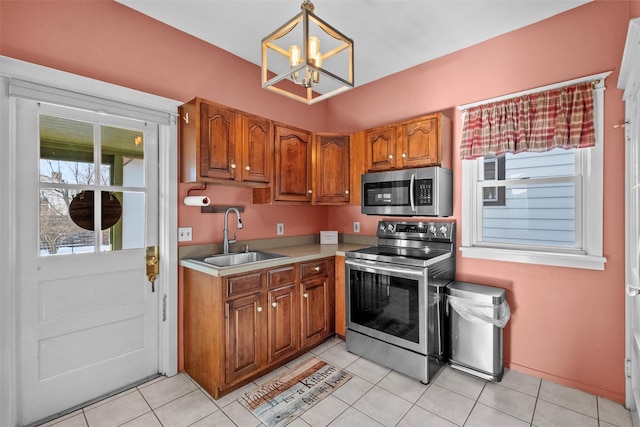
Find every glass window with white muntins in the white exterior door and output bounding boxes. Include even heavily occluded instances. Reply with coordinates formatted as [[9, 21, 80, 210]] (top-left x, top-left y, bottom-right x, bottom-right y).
[[39, 115, 146, 256]]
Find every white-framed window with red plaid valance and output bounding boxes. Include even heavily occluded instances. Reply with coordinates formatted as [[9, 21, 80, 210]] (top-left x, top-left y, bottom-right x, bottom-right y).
[[460, 73, 608, 269]]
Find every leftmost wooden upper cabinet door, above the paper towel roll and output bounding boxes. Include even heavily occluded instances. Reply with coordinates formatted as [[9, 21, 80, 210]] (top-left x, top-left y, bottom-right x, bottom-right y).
[[199, 102, 237, 179]]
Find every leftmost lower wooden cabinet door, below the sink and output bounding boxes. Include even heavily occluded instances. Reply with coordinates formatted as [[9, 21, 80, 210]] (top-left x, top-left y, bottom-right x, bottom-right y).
[[225, 293, 264, 383]]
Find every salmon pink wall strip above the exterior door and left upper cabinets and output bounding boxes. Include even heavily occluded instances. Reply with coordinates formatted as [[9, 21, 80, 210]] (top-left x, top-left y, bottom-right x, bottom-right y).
[[0, 0, 327, 130]]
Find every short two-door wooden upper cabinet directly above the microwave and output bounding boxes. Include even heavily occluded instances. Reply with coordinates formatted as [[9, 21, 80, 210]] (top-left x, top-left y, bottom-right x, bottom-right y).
[[365, 113, 451, 172]]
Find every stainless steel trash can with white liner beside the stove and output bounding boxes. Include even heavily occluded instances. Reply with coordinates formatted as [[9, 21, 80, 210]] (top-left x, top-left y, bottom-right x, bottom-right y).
[[447, 281, 510, 381]]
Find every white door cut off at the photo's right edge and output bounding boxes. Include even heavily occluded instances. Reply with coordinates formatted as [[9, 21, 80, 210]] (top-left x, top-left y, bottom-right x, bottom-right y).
[[618, 18, 640, 426]]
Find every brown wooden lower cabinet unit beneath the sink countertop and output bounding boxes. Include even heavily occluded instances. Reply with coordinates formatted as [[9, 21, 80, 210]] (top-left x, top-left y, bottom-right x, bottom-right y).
[[184, 257, 335, 399]]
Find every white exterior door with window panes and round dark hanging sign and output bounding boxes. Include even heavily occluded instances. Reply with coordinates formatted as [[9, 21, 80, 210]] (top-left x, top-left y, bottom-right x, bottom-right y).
[[16, 99, 159, 425]]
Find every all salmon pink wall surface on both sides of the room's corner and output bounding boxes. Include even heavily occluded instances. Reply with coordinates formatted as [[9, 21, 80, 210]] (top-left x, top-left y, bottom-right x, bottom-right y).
[[0, 0, 640, 402]]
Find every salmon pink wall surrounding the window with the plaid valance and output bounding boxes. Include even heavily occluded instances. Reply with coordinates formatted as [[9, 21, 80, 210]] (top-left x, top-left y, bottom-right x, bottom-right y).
[[328, 1, 638, 402]]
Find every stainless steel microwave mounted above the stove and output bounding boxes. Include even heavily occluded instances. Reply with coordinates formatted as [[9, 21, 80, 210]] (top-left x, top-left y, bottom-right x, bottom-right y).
[[361, 166, 453, 216]]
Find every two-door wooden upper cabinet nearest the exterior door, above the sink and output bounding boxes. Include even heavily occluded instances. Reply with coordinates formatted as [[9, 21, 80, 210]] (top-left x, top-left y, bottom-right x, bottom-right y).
[[180, 98, 273, 184]]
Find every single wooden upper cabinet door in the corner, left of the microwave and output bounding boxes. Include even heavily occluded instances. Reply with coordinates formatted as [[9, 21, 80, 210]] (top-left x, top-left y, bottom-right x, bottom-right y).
[[314, 135, 350, 204]]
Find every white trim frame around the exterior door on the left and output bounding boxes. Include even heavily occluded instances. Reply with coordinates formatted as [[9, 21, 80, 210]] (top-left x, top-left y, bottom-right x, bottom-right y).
[[0, 56, 181, 426]]
